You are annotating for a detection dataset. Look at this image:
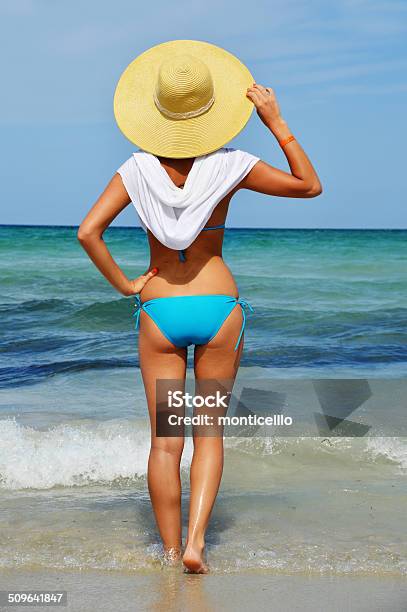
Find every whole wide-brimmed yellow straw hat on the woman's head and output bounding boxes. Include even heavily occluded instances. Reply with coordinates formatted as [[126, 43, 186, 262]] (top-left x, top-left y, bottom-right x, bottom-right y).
[[113, 40, 254, 158]]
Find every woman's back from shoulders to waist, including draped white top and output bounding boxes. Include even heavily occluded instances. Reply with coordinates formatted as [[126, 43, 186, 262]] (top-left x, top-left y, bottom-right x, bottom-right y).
[[118, 148, 259, 301]]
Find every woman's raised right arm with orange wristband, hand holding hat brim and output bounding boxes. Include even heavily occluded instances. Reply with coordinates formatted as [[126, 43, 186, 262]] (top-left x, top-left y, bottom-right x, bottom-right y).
[[244, 84, 322, 198]]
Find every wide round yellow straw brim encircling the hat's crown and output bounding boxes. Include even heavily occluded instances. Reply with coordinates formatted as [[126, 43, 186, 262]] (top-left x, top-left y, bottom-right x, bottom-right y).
[[113, 40, 254, 158]]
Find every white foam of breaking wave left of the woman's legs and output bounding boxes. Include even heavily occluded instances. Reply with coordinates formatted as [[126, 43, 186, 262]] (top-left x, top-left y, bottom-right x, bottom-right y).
[[0, 419, 195, 489]]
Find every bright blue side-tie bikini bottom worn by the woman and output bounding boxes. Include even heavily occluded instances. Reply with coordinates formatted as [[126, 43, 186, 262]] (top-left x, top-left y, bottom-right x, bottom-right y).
[[133, 294, 253, 351]]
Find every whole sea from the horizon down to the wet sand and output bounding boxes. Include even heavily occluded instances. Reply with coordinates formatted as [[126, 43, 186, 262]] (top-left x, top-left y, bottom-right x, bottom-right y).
[[0, 225, 407, 576]]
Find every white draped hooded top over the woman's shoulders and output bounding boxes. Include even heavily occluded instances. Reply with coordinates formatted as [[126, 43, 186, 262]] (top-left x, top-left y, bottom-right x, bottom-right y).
[[117, 147, 260, 250]]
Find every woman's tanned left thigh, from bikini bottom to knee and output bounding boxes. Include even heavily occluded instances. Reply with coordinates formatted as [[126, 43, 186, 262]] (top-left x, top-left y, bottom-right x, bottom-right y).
[[139, 311, 187, 452]]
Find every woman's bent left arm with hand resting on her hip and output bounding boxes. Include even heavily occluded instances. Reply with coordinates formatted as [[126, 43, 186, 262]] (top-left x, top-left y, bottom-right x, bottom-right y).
[[77, 173, 158, 296]]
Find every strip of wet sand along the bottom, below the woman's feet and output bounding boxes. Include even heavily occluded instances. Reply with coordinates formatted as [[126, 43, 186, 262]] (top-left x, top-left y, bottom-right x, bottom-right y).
[[0, 568, 407, 612]]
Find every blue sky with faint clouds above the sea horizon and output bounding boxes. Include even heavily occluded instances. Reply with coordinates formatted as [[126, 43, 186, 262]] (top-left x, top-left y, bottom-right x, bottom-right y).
[[0, 0, 407, 228]]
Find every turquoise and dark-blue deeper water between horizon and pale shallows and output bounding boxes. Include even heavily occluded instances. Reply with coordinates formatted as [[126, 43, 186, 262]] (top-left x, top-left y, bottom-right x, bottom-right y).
[[0, 226, 407, 386]]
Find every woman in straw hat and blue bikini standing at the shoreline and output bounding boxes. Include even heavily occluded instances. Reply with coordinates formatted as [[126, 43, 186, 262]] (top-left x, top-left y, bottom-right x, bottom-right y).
[[78, 41, 322, 573]]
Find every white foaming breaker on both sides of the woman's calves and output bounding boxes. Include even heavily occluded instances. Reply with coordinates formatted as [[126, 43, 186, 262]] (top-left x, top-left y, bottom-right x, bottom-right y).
[[0, 419, 407, 490]]
